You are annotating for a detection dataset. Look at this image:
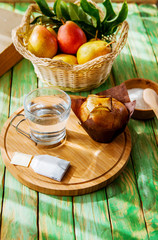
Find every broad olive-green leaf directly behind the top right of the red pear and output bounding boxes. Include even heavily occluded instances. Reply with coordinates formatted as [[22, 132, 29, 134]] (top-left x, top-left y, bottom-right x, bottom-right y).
[[69, 2, 92, 24]]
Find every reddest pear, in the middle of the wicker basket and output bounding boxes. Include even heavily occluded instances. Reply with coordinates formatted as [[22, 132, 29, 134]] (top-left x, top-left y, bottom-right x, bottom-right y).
[[57, 21, 87, 54]]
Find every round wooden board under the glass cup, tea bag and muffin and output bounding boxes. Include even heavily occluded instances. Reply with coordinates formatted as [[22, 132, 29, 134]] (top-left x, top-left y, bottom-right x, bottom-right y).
[[1, 108, 131, 196]]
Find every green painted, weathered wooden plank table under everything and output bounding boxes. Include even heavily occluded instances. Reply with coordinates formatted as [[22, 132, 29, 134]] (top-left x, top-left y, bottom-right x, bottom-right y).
[[0, 3, 158, 240]]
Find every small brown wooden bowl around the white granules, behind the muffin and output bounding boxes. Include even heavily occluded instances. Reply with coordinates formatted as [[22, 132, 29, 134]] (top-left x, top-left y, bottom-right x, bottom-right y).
[[124, 78, 158, 120]]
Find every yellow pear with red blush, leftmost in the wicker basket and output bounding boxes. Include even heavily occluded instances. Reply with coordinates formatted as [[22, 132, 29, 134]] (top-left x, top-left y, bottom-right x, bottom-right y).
[[28, 25, 58, 58]]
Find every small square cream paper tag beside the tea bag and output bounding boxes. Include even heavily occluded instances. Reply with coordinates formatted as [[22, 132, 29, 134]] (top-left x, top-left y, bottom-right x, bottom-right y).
[[10, 152, 32, 167]]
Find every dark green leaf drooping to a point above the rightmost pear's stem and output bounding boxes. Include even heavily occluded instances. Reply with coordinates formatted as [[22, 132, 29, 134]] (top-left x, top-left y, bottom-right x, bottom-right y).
[[80, 0, 100, 29]]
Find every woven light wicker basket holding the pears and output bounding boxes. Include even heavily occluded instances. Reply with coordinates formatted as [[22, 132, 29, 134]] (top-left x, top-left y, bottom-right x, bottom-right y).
[[12, 1, 129, 92]]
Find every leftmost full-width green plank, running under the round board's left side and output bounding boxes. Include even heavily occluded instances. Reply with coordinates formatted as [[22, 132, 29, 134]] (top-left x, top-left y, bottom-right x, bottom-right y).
[[1, 59, 38, 239]]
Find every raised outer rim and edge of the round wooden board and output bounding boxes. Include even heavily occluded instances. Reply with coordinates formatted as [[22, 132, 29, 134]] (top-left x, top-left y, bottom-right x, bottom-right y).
[[1, 107, 131, 196]]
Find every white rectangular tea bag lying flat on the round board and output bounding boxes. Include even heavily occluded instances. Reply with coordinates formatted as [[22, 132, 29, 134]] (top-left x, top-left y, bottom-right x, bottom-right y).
[[30, 155, 70, 181]]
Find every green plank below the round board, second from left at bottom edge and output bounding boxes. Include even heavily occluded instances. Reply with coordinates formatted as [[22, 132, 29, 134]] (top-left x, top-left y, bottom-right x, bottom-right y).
[[39, 193, 75, 240]]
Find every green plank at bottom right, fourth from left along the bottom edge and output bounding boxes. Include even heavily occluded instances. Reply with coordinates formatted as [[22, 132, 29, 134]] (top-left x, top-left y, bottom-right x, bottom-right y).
[[107, 160, 148, 240]]
